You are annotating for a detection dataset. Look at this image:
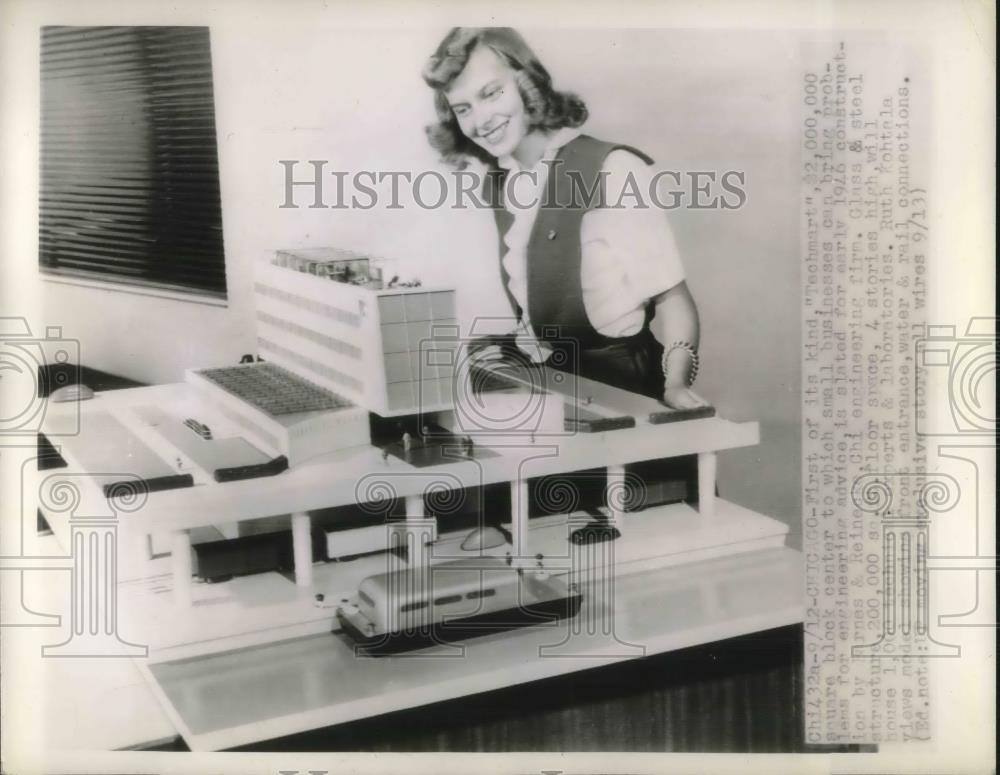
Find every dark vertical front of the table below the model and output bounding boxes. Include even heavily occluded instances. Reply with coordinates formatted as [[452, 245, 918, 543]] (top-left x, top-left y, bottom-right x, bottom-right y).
[[238, 625, 807, 753]]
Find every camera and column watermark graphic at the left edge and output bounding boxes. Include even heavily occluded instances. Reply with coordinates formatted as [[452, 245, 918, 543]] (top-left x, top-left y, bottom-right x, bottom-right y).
[[0, 317, 148, 657]]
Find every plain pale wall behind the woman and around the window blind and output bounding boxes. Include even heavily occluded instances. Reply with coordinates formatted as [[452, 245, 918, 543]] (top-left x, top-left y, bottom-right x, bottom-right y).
[[31, 19, 800, 531]]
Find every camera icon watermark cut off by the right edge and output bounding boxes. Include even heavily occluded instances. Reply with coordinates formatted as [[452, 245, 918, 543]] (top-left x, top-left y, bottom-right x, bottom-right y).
[[915, 317, 997, 436]]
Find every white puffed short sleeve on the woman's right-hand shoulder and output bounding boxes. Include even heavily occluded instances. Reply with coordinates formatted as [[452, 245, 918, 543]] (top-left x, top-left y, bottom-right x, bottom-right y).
[[580, 150, 684, 336]]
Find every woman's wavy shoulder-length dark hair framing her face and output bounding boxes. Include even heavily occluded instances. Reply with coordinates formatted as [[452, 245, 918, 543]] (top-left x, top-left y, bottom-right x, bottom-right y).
[[423, 27, 587, 168]]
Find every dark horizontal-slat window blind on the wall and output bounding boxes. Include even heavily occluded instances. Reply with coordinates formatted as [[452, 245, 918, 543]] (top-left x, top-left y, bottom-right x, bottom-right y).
[[39, 27, 226, 297]]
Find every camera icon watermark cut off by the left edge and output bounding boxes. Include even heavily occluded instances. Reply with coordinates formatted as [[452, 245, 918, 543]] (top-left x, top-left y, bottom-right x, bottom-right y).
[[0, 317, 80, 445]]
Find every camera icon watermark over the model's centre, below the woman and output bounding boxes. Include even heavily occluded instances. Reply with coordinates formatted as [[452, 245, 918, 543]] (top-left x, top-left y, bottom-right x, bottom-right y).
[[418, 321, 580, 444]]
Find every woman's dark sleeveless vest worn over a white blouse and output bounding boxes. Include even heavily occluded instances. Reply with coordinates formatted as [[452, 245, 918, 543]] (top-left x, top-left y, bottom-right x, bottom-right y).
[[484, 135, 663, 398]]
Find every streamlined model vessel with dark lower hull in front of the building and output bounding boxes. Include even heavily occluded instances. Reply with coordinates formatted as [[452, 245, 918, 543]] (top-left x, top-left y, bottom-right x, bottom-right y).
[[336, 556, 581, 656]]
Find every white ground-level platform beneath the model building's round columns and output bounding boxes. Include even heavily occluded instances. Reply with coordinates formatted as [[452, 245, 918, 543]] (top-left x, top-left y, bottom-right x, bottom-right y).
[[119, 500, 788, 662]]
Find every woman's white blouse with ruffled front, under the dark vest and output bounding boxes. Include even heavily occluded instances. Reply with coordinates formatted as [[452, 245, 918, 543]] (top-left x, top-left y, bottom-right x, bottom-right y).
[[497, 128, 684, 361]]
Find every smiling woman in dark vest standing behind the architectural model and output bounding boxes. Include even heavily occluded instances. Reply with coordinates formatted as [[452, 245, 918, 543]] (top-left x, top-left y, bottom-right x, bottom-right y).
[[424, 27, 705, 409]]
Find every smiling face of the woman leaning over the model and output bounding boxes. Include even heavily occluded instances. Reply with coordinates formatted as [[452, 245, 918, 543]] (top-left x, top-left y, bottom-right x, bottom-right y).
[[445, 46, 528, 157]]
